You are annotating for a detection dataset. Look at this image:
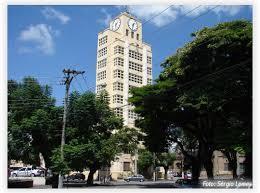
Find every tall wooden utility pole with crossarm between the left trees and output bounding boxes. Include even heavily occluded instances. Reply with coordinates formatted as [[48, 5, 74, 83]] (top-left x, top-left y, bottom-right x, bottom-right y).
[[58, 69, 85, 188]]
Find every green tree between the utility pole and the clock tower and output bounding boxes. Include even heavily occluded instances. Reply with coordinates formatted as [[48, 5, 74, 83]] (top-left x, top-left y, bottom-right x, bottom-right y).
[[52, 92, 123, 184]]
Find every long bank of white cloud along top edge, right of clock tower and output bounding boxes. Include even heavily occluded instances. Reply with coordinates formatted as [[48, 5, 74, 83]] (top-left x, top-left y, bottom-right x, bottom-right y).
[[119, 5, 245, 27]]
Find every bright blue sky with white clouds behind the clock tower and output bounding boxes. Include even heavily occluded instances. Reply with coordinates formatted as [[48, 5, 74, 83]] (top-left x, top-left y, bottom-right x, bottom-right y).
[[8, 5, 252, 105]]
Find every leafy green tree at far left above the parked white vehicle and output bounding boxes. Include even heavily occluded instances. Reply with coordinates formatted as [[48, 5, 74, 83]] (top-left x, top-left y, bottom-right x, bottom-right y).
[[8, 77, 61, 167]]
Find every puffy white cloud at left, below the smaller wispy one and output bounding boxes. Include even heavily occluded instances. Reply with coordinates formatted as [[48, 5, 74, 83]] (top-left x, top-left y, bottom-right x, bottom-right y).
[[18, 24, 58, 55]]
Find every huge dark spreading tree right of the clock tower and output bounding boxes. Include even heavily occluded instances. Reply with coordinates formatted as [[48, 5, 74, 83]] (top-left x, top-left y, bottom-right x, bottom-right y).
[[130, 21, 252, 178]]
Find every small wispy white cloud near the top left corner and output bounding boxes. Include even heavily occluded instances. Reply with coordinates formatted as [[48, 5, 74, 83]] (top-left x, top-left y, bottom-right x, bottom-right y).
[[42, 7, 70, 24]]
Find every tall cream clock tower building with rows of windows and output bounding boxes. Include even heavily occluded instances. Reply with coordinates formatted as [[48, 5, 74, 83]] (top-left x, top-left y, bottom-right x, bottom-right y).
[[96, 12, 152, 178]]
